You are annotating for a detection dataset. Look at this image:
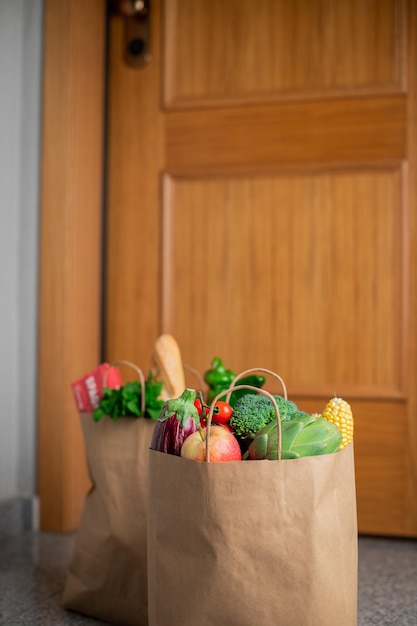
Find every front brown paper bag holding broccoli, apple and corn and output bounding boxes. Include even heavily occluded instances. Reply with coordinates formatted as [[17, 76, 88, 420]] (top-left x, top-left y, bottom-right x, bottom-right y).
[[148, 380, 357, 626]]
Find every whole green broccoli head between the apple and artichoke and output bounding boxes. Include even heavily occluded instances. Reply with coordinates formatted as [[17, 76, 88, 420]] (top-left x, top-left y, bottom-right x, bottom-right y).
[[230, 394, 306, 439]]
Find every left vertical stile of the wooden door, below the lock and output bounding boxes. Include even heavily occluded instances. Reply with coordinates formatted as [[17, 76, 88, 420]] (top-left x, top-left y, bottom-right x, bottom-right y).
[[104, 2, 164, 372]]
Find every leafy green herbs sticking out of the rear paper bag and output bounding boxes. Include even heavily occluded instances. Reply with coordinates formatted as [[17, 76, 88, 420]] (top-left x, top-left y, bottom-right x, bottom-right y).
[[93, 372, 164, 422]]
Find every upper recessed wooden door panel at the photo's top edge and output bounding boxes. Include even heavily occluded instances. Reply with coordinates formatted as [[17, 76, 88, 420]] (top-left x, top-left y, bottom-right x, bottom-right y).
[[164, 0, 405, 107]]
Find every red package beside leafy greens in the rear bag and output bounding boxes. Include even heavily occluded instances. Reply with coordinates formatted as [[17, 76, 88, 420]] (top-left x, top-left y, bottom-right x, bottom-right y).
[[71, 363, 122, 413]]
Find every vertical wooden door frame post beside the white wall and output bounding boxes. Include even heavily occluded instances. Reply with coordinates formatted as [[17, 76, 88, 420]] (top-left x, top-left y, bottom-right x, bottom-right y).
[[38, 0, 105, 531]]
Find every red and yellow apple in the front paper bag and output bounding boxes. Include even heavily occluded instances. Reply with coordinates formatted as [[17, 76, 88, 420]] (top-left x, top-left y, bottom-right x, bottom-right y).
[[181, 426, 242, 463]]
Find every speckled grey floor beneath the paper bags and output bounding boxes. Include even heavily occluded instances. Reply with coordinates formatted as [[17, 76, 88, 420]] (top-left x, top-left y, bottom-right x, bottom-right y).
[[0, 532, 417, 626]]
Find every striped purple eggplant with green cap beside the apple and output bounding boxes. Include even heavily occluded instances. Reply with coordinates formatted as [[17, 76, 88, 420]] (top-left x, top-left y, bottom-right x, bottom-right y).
[[151, 389, 200, 456]]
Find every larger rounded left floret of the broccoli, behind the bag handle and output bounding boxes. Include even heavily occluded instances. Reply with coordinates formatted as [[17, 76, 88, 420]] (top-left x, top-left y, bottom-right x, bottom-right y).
[[230, 393, 276, 439]]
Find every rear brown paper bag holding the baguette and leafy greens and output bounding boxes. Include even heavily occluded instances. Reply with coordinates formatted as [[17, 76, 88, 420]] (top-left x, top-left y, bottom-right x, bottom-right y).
[[63, 413, 155, 626]]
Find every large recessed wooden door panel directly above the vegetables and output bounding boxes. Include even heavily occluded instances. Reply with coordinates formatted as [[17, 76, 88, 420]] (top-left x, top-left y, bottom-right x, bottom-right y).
[[163, 167, 405, 398]]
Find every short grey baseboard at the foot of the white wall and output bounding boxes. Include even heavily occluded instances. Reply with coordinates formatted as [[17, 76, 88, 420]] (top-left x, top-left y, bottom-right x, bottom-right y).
[[0, 496, 39, 537]]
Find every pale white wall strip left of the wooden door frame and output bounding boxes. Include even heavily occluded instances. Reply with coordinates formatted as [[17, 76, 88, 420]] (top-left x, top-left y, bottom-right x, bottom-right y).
[[0, 0, 43, 502]]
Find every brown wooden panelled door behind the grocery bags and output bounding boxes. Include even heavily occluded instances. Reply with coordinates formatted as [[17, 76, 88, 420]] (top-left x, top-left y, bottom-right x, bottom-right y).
[[105, 0, 417, 536]]
